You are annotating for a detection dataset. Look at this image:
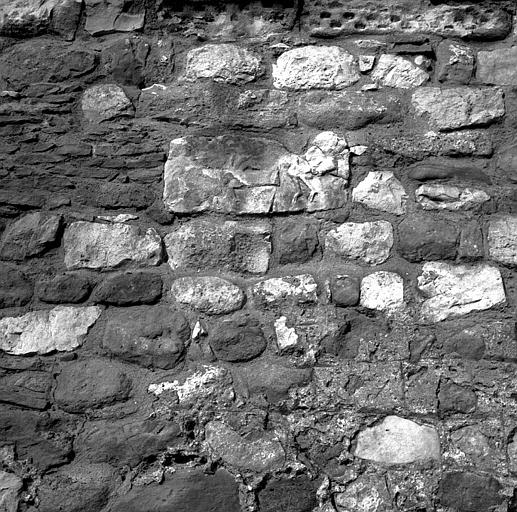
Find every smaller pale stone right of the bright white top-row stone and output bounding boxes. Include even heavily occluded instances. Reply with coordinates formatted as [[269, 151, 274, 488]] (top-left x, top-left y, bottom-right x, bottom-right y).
[[371, 54, 429, 89]]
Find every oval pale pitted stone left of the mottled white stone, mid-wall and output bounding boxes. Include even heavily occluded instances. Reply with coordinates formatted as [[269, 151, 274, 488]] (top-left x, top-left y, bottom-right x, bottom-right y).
[[171, 276, 244, 315]]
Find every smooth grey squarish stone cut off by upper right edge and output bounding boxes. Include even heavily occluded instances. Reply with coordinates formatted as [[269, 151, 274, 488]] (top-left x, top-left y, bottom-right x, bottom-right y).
[[476, 46, 517, 85]]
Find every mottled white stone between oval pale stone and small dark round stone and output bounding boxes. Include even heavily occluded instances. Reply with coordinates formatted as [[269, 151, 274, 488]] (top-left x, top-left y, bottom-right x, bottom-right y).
[[249, 274, 318, 308]]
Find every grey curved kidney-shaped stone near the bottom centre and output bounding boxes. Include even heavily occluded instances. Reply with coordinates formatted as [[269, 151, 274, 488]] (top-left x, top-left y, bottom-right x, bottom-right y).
[[205, 421, 285, 473]]
